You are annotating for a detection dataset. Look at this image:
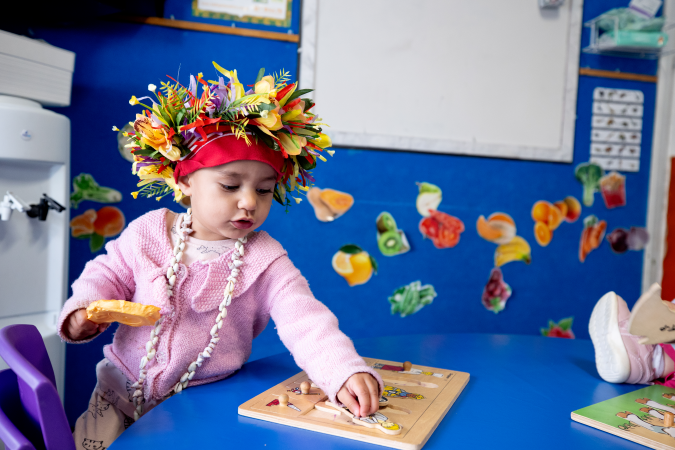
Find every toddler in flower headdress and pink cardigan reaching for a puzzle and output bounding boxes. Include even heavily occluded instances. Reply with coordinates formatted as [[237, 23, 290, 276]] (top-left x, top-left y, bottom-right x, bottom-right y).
[[58, 63, 383, 447]]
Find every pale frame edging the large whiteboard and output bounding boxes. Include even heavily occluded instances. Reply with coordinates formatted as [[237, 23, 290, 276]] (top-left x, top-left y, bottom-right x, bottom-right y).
[[298, 0, 583, 163]]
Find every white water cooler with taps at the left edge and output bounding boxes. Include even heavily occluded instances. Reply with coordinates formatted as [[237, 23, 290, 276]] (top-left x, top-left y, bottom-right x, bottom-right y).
[[0, 31, 75, 414]]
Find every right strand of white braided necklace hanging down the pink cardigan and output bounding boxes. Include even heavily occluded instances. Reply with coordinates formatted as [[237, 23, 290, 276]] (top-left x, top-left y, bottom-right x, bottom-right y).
[[173, 232, 247, 393]]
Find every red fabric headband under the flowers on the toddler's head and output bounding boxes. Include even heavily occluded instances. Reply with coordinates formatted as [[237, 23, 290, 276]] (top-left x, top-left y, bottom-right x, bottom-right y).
[[173, 133, 284, 182]]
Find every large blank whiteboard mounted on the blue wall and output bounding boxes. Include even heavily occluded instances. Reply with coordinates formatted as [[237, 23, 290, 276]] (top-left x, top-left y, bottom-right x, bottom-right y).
[[300, 0, 582, 162]]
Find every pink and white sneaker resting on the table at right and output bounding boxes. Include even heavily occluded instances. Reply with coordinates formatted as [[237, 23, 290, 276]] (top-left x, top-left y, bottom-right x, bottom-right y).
[[588, 292, 657, 384]]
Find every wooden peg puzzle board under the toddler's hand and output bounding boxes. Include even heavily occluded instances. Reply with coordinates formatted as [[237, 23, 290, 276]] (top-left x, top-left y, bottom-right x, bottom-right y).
[[239, 358, 469, 450]]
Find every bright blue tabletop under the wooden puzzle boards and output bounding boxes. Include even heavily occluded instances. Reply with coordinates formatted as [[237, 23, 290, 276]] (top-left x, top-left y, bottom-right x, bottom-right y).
[[109, 334, 645, 450]]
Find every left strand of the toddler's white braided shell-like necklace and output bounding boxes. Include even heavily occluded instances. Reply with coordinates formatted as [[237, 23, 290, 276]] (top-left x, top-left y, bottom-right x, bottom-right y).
[[131, 208, 192, 420]]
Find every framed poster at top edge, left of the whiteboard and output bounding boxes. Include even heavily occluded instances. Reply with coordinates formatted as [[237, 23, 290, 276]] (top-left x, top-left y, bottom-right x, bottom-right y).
[[192, 0, 293, 28]]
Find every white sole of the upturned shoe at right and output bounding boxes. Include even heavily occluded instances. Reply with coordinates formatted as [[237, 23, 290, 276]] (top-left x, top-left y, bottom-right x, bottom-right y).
[[588, 292, 630, 383]]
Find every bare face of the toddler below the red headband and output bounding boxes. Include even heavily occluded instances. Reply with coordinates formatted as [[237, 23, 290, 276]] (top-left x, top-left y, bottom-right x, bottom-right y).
[[178, 161, 277, 241]]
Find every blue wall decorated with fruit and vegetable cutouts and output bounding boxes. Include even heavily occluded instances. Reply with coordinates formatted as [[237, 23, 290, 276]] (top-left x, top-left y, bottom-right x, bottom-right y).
[[27, 0, 656, 421]]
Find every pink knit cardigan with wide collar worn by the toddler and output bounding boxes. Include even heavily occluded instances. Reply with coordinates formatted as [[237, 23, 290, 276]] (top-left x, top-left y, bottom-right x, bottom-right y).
[[58, 209, 383, 401]]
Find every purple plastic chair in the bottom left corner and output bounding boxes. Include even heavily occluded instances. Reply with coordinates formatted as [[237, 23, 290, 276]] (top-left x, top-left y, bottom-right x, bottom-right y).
[[0, 325, 75, 450]]
